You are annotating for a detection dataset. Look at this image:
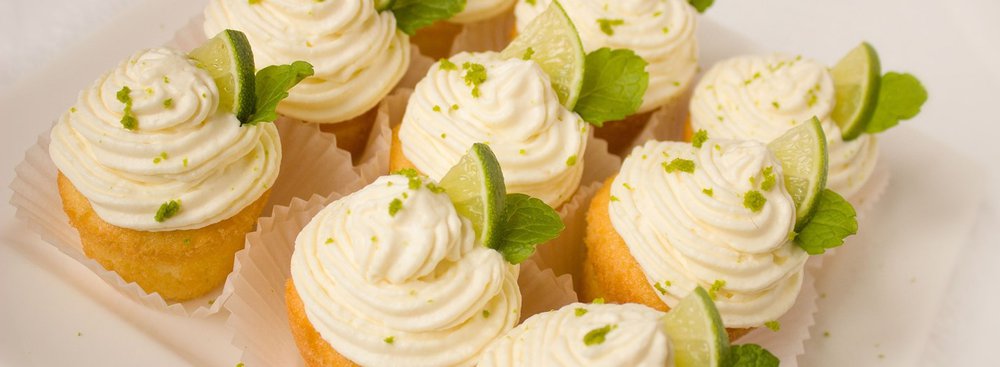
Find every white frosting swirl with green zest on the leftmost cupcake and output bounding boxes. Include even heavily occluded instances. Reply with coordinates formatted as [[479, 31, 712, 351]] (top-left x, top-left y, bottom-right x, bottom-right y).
[[49, 48, 281, 231]]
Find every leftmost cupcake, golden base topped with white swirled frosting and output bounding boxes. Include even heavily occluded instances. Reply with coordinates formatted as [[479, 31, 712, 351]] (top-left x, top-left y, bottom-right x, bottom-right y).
[[49, 48, 281, 301]]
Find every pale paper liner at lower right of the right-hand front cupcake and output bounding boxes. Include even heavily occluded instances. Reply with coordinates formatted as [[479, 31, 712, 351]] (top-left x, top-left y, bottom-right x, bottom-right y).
[[735, 256, 822, 367]]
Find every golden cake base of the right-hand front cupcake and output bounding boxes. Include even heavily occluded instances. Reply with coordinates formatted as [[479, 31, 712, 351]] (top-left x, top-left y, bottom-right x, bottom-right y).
[[580, 176, 753, 341]]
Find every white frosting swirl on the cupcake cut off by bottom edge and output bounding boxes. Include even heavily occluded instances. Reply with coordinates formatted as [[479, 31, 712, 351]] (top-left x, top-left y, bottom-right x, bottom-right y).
[[479, 303, 674, 367]]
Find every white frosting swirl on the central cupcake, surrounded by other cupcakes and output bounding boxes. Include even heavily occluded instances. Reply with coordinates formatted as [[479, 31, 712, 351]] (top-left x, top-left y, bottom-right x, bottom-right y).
[[399, 52, 590, 207]]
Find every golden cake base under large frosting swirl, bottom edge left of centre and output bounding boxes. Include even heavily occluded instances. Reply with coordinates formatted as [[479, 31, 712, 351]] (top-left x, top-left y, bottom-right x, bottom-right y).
[[285, 278, 358, 367]]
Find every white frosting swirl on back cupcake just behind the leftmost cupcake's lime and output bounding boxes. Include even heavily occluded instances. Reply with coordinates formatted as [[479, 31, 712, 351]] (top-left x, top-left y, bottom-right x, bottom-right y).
[[205, 0, 410, 123]]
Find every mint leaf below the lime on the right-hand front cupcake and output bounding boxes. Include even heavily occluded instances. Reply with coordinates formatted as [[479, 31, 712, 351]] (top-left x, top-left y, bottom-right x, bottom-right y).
[[795, 189, 858, 255]]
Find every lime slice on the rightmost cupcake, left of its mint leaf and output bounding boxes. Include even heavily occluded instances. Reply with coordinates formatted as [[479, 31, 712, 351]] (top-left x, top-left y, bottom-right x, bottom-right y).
[[830, 42, 882, 141]]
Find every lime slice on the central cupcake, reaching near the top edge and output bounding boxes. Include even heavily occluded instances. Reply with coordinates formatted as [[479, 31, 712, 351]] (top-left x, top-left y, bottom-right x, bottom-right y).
[[500, 0, 587, 110]]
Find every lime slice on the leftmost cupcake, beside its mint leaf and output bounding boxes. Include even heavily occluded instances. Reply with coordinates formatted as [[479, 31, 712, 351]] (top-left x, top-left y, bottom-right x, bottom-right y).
[[188, 29, 257, 121]]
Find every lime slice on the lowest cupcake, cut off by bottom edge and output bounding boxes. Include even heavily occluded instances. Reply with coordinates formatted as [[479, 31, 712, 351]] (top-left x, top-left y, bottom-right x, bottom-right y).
[[663, 287, 729, 367]]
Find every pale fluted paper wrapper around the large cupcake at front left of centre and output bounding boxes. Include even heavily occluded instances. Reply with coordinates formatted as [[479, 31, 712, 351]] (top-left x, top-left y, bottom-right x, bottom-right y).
[[225, 194, 577, 366]]
